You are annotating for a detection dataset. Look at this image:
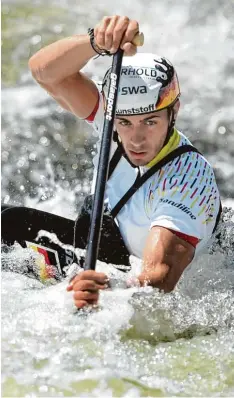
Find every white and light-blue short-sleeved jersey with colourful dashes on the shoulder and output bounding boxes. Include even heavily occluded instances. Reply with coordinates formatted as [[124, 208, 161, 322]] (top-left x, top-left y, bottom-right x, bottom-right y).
[[85, 95, 220, 258]]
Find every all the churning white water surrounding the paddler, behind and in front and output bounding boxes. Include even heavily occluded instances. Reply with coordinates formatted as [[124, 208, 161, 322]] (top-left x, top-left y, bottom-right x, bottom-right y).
[[2, 0, 234, 397]]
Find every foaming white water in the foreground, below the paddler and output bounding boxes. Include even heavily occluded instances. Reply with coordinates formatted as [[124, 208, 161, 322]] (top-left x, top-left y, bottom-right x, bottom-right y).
[[2, 235, 234, 397]]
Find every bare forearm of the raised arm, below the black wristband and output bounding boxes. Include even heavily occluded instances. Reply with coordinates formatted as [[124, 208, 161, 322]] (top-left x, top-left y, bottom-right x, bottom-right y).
[[29, 35, 96, 84]]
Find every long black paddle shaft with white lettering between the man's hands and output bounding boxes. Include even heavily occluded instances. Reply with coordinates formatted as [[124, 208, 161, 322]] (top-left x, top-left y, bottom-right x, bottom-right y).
[[84, 49, 123, 270]]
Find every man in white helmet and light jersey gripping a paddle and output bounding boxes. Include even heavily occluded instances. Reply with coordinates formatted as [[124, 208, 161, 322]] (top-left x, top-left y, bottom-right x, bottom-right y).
[[14, 16, 220, 308]]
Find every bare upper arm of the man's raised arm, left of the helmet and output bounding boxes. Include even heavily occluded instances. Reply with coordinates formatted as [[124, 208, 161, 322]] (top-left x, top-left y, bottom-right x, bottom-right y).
[[39, 72, 99, 119]]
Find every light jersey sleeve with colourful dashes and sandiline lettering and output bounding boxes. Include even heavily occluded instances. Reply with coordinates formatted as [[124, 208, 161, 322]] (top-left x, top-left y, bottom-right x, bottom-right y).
[[150, 153, 220, 241]]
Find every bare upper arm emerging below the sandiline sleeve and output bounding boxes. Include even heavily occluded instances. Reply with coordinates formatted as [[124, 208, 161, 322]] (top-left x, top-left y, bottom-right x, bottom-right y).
[[143, 226, 195, 291]]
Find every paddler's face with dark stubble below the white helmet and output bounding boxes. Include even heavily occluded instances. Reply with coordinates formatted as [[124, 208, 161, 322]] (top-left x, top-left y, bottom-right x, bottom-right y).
[[115, 109, 178, 166]]
